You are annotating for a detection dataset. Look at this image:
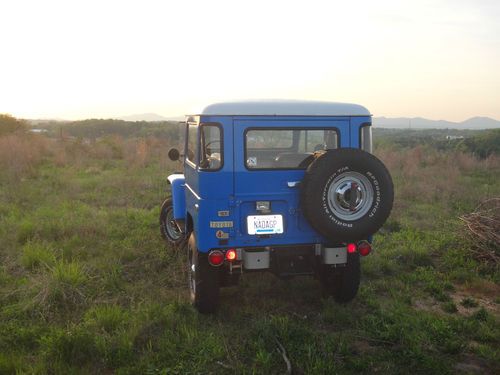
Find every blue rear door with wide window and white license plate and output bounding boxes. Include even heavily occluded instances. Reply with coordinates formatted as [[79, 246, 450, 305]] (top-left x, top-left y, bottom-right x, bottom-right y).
[[233, 117, 350, 245]]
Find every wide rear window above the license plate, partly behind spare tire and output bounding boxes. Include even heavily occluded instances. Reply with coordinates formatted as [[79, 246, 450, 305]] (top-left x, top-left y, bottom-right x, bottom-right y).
[[245, 128, 339, 169]]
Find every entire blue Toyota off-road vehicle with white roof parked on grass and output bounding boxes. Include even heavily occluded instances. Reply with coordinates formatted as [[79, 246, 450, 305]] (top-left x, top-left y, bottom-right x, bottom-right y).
[[160, 101, 394, 313]]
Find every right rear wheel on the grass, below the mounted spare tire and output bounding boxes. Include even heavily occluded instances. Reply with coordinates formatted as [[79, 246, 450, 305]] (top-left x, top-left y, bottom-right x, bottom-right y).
[[320, 253, 361, 303]]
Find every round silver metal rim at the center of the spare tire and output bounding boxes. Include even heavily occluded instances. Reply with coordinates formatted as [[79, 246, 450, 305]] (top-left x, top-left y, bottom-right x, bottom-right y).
[[327, 172, 374, 221]]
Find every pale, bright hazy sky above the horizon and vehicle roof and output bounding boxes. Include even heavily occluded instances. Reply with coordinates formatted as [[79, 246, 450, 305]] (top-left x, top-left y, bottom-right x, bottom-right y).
[[0, 0, 500, 121]]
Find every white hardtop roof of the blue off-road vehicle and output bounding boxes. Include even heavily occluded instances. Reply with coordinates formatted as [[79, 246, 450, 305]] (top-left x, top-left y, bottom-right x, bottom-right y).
[[197, 100, 371, 116]]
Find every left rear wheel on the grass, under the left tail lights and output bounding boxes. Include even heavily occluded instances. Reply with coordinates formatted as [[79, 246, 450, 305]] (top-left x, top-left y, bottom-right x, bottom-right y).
[[187, 233, 220, 314]]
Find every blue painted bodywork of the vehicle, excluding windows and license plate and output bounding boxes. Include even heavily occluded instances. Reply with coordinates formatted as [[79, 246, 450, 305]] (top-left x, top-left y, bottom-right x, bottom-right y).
[[168, 115, 371, 252]]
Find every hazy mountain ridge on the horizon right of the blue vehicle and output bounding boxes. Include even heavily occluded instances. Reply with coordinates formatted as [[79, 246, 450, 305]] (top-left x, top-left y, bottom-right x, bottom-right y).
[[373, 117, 500, 129]]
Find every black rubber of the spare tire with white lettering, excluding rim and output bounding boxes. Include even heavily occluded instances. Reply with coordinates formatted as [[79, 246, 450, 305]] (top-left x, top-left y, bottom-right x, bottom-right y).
[[300, 148, 394, 243]]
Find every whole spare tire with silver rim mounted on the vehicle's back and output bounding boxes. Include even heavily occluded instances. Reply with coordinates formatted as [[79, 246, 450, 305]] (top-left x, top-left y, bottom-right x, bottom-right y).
[[301, 148, 394, 242]]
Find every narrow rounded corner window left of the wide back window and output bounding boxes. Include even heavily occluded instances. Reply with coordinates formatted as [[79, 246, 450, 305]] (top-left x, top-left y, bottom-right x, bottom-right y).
[[200, 124, 223, 171]]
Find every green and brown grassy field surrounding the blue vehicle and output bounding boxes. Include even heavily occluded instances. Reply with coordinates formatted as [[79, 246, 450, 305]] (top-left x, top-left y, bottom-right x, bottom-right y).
[[0, 136, 500, 374]]
